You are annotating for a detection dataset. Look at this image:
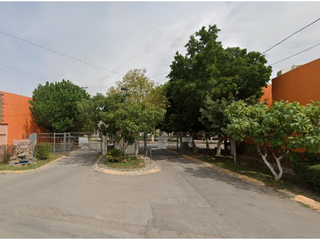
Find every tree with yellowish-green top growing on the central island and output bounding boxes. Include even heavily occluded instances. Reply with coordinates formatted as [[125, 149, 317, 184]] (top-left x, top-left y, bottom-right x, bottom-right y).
[[100, 69, 167, 154]]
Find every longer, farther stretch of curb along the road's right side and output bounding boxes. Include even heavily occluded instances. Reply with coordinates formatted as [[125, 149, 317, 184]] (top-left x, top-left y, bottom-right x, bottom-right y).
[[167, 150, 265, 186]]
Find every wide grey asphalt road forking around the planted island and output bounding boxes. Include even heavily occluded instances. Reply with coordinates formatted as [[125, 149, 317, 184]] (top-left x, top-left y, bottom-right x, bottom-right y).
[[0, 150, 320, 238]]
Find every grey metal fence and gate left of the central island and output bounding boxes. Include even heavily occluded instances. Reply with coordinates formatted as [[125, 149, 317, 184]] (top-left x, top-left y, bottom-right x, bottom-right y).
[[37, 132, 106, 155]]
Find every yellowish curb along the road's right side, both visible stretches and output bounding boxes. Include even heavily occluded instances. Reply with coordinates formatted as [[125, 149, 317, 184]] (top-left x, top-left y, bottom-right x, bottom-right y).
[[167, 150, 320, 212]]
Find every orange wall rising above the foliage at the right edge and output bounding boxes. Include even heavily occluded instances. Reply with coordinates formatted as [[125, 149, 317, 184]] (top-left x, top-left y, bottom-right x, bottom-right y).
[[272, 58, 320, 105]]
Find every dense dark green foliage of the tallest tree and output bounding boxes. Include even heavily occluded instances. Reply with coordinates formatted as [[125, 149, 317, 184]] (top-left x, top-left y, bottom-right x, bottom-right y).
[[165, 25, 271, 132]]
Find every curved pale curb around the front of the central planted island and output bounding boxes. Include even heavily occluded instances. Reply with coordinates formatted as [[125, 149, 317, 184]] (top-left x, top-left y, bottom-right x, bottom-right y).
[[92, 155, 161, 176]]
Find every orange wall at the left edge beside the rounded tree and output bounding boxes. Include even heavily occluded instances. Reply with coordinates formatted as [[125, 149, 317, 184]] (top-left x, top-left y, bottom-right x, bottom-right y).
[[0, 92, 45, 145]]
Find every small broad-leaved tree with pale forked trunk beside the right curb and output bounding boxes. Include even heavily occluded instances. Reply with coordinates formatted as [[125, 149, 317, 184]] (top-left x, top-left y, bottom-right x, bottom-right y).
[[226, 100, 312, 181]]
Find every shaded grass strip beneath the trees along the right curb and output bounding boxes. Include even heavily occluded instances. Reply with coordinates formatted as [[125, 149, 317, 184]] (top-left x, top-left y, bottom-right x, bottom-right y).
[[193, 156, 320, 201]]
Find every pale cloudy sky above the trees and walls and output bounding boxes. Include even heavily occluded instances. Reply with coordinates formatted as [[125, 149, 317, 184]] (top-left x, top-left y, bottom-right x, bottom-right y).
[[0, 1, 320, 97]]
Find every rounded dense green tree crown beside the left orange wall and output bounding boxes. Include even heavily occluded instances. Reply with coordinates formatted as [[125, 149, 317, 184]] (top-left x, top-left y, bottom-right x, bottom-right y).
[[30, 80, 90, 132]]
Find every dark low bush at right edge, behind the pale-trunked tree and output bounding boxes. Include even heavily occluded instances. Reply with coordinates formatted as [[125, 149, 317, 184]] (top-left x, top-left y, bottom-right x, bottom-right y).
[[292, 155, 320, 191]]
